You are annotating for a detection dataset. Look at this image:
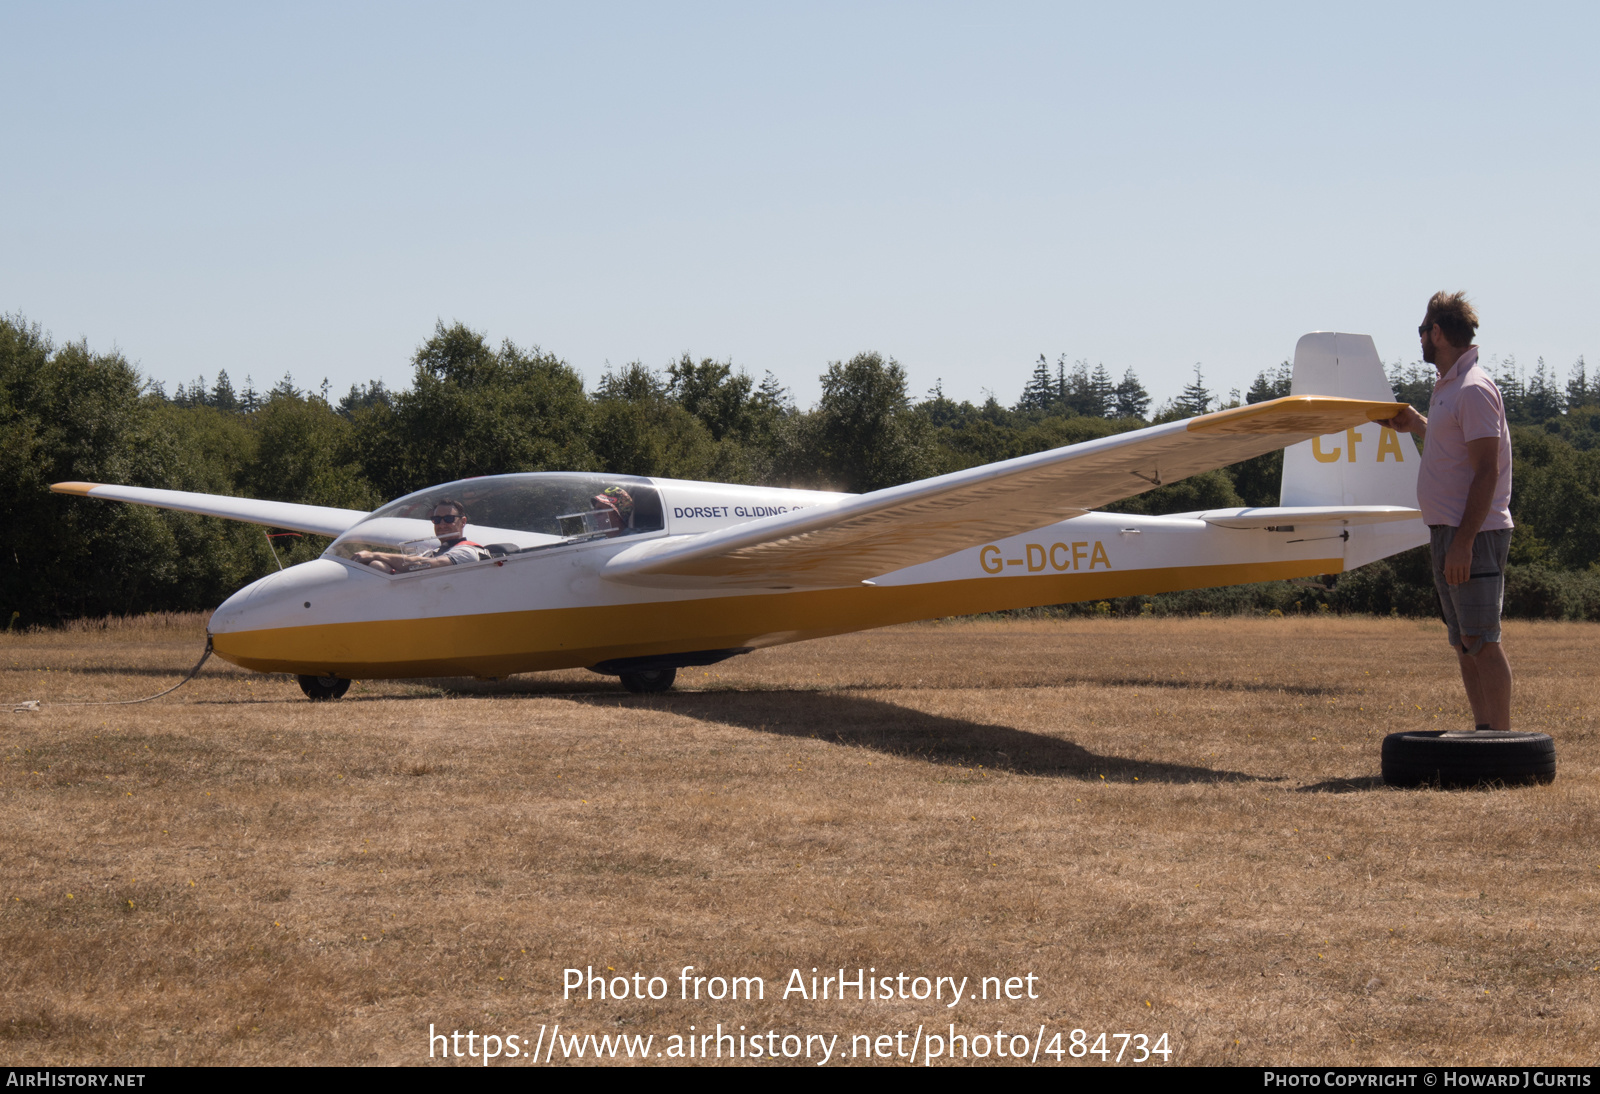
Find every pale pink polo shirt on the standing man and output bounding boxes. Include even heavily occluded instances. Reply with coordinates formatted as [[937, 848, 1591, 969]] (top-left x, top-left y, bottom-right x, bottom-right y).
[[1416, 345, 1512, 531]]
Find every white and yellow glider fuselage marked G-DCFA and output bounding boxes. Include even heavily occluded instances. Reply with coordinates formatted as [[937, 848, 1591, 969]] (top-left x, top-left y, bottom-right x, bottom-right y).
[[211, 480, 1366, 678]]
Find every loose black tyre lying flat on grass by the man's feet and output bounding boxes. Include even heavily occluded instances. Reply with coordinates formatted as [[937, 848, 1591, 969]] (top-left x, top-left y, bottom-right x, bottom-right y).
[[1382, 729, 1555, 787]]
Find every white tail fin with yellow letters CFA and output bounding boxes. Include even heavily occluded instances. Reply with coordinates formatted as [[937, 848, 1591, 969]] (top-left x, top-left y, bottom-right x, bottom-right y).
[[1280, 331, 1427, 569]]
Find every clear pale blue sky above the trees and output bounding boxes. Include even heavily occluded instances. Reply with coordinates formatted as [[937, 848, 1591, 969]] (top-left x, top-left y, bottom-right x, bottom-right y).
[[0, 2, 1600, 406]]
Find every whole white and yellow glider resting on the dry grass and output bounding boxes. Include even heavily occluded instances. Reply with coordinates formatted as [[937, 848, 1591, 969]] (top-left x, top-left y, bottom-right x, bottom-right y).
[[53, 334, 1427, 697]]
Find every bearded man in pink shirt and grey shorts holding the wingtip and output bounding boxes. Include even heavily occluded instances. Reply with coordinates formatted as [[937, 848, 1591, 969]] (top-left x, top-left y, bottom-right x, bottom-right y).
[[1384, 293, 1512, 731]]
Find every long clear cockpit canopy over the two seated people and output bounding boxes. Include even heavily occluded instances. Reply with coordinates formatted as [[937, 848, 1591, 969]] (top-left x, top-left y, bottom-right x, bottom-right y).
[[325, 472, 664, 569]]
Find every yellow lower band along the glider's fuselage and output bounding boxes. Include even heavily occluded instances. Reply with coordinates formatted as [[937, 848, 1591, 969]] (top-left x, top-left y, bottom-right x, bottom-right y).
[[213, 558, 1344, 680]]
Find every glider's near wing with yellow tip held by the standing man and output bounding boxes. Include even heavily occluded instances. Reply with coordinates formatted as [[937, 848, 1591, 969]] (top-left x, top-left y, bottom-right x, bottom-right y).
[[602, 395, 1403, 589]]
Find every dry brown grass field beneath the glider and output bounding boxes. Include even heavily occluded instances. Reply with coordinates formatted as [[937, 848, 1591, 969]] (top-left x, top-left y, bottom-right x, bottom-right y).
[[0, 617, 1600, 1067]]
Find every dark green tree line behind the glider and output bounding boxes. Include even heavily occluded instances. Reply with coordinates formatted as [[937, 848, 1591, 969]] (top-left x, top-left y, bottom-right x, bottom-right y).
[[0, 317, 1600, 625]]
